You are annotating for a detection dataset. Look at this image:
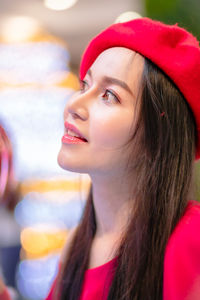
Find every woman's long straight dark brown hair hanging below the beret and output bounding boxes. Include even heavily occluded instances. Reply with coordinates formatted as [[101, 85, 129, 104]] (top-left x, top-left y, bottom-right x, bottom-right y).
[[60, 58, 196, 300]]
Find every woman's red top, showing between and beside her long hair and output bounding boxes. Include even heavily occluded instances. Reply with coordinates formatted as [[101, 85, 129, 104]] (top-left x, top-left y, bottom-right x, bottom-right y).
[[46, 201, 200, 300]]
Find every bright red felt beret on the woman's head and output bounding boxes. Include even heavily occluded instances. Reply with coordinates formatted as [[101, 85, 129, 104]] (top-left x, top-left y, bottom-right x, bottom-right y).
[[80, 18, 200, 159]]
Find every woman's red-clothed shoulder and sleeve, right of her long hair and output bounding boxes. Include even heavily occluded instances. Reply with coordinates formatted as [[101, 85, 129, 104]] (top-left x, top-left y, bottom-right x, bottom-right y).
[[164, 201, 200, 300]]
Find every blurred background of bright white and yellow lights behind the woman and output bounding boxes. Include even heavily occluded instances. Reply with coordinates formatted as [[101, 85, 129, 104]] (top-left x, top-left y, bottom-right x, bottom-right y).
[[0, 0, 200, 300]]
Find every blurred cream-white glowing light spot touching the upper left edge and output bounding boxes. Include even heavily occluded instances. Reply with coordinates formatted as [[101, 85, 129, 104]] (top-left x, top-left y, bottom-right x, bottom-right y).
[[0, 16, 40, 43]]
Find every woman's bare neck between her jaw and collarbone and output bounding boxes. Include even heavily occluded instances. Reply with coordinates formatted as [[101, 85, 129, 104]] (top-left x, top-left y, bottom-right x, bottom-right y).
[[92, 176, 133, 237]]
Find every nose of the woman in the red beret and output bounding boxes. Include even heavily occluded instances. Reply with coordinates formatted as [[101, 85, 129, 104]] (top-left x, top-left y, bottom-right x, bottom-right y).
[[64, 93, 89, 120]]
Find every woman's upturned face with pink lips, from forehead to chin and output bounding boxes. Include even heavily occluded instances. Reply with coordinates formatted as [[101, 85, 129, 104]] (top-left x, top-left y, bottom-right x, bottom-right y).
[[58, 47, 144, 176]]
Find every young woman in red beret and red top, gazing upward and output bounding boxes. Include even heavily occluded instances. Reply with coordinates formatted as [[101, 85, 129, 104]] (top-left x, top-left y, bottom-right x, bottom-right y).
[[0, 18, 200, 300]]
